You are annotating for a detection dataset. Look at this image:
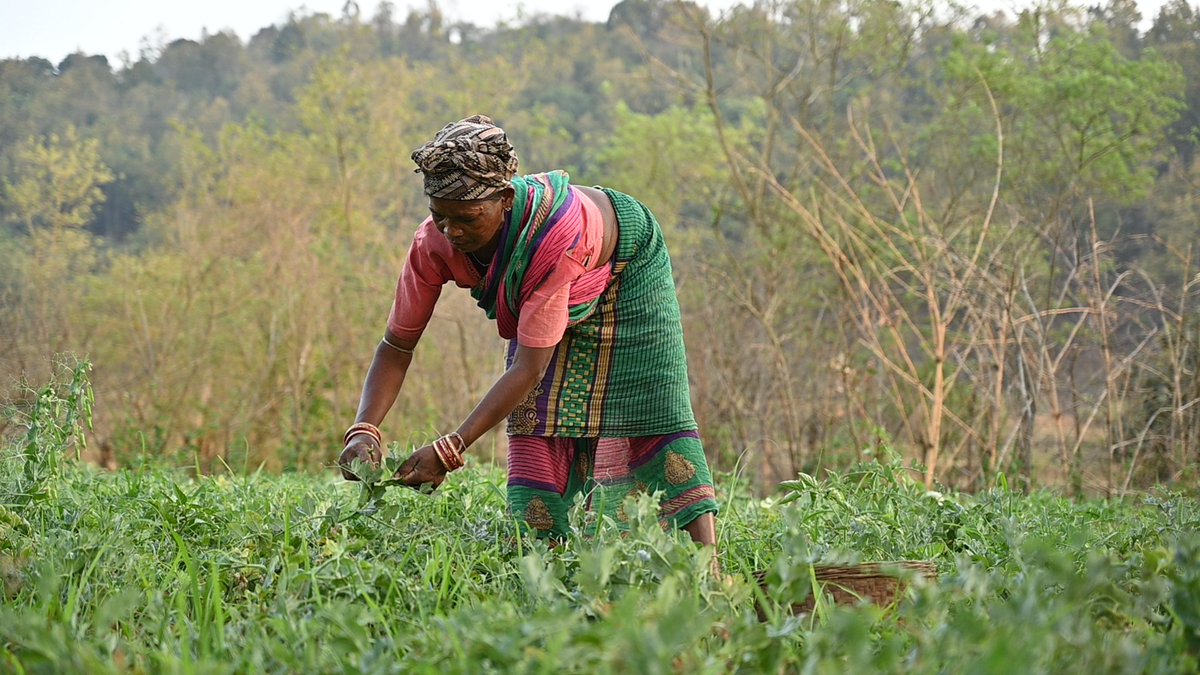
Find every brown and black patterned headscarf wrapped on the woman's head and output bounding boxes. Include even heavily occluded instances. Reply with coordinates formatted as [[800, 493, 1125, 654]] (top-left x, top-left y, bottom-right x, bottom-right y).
[[413, 115, 517, 199]]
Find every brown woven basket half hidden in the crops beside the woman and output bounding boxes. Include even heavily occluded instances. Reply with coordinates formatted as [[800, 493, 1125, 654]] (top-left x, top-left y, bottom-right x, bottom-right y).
[[756, 560, 937, 619]]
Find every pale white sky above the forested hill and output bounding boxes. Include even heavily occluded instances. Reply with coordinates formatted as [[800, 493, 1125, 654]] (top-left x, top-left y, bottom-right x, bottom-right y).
[[0, 0, 1164, 67]]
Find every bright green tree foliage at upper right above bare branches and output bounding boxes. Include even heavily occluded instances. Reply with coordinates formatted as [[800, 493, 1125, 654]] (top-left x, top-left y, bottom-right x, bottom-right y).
[[947, 23, 1183, 202]]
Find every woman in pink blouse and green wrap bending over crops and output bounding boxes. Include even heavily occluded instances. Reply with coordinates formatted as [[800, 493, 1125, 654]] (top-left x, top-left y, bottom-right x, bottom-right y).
[[340, 115, 716, 545]]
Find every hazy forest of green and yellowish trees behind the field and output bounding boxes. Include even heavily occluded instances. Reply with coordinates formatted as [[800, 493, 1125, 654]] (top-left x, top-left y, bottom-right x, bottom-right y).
[[0, 0, 1200, 496]]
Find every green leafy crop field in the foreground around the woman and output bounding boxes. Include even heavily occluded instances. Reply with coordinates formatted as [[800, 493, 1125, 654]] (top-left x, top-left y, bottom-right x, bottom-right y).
[[0, 367, 1200, 674]]
